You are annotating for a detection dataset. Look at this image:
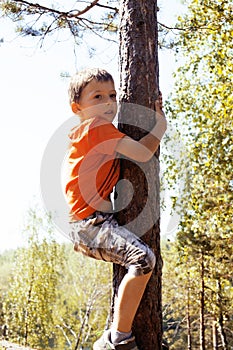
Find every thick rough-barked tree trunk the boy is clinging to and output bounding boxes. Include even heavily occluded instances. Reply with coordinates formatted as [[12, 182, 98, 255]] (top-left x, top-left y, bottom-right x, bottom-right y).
[[113, 0, 162, 350]]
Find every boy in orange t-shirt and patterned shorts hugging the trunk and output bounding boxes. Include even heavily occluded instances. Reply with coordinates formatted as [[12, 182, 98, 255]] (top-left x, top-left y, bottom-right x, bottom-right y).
[[66, 69, 166, 350]]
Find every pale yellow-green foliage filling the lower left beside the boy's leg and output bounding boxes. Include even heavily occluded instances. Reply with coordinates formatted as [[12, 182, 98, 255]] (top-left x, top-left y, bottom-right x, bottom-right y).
[[0, 210, 112, 349]]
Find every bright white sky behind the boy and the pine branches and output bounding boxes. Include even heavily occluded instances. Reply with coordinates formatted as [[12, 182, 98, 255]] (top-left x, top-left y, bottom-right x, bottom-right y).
[[0, 0, 186, 253]]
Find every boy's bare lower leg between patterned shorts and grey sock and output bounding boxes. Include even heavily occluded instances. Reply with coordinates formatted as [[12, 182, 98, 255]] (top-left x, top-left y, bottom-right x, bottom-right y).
[[113, 272, 152, 333]]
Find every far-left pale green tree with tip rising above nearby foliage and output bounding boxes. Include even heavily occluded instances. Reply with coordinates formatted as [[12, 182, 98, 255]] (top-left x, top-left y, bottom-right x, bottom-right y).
[[4, 209, 63, 348]]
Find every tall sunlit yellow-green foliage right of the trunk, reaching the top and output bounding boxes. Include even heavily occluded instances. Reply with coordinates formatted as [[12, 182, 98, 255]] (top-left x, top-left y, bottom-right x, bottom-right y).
[[162, 0, 233, 349]]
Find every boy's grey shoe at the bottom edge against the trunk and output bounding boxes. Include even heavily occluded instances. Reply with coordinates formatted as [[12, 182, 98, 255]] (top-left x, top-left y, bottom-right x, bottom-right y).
[[93, 329, 139, 350]]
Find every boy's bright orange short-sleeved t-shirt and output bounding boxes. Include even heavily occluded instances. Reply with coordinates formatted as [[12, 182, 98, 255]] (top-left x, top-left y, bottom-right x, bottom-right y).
[[66, 117, 125, 220]]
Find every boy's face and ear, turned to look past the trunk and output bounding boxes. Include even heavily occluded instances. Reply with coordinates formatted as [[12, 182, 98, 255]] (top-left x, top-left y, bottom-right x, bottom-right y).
[[71, 79, 117, 122]]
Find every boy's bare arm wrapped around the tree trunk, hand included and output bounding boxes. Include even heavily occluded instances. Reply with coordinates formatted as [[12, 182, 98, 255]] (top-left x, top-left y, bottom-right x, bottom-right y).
[[116, 100, 167, 162]]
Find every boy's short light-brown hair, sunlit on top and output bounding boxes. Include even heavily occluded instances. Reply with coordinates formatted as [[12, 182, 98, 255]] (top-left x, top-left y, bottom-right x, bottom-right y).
[[68, 68, 114, 103]]
